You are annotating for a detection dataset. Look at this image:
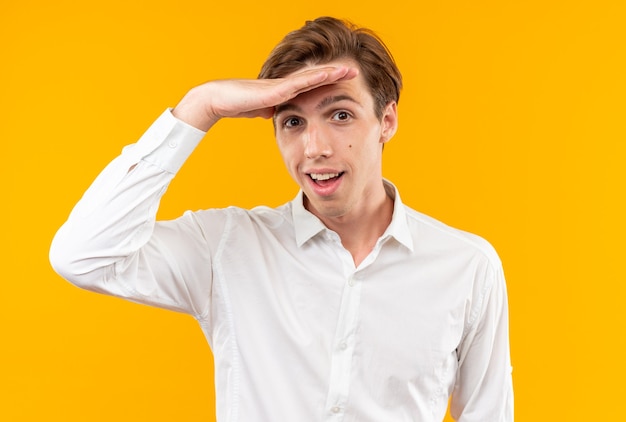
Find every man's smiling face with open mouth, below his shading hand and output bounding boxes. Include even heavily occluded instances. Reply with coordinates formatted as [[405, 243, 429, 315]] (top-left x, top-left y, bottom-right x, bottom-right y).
[[274, 61, 397, 221]]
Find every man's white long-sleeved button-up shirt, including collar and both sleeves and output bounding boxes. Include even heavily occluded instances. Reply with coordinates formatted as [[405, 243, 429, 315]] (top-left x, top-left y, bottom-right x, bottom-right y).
[[50, 111, 513, 422]]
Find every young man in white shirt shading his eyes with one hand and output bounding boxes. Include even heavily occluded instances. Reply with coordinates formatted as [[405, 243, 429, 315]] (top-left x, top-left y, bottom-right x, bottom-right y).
[[50, 18, 513, 422]]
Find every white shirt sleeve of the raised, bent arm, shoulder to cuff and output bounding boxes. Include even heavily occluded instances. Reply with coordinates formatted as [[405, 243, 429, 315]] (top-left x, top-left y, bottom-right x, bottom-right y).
[[50, 109, 210, 316]]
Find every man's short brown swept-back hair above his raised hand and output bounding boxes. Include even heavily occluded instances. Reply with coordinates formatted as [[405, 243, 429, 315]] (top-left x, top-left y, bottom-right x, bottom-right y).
[[259, 17, 402, 118]]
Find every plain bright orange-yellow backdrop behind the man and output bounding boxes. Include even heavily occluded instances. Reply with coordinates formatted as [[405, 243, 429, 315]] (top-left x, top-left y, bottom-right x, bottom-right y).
[[0, 0, 626, 422]]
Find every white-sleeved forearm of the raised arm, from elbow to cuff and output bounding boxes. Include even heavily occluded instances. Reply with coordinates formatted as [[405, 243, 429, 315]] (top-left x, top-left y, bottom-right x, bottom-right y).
[[50, 111, 203, 290]]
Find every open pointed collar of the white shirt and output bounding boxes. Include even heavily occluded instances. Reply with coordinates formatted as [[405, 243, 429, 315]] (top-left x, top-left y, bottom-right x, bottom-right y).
[[291, 179, 413, 251]]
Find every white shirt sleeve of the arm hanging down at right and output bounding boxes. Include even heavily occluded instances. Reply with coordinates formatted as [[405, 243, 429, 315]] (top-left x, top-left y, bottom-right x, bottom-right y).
[[450, 266, 513, 422]]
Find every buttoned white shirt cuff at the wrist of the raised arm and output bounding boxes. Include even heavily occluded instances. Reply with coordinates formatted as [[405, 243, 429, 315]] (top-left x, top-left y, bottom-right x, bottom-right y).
[[124, 108, 206, 173]]
